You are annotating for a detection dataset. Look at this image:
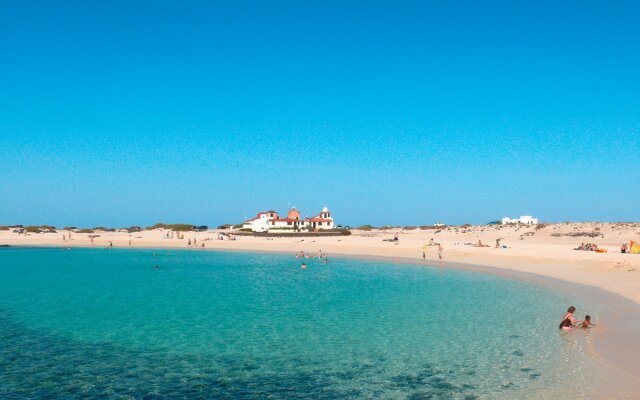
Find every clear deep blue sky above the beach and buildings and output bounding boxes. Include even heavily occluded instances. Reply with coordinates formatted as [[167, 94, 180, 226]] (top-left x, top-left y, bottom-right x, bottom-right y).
[[0, 0, 640, 227]]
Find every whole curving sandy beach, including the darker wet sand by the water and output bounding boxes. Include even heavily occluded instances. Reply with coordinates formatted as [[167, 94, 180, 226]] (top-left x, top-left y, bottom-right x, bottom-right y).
[[0, 223, 640, 388]]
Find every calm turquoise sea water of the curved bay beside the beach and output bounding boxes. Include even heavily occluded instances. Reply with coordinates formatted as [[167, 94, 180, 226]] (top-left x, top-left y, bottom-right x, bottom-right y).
[[0, 248, 604, 399]]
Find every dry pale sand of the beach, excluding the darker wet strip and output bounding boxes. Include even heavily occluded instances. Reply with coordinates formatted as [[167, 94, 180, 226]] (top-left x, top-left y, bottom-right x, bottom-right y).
[[0, 223, 640, 304]]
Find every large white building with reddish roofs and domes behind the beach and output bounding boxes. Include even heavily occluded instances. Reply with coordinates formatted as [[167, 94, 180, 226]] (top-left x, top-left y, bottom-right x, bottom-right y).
[[242, 207, 335, 233]]
